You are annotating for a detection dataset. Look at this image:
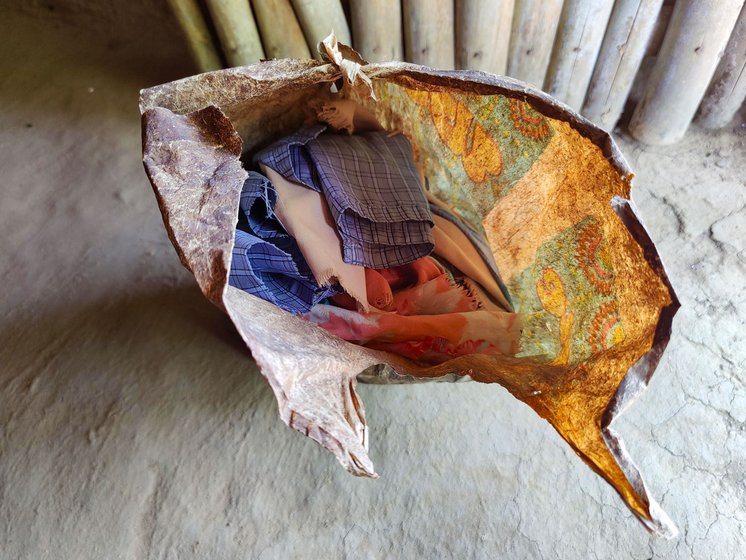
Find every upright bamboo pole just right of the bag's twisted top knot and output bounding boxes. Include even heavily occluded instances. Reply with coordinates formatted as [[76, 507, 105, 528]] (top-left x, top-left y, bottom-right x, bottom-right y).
[[350, 0, 404, 62]]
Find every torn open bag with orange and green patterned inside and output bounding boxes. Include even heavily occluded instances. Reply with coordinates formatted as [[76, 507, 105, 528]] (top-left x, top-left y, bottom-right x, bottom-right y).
[[140, 40, 678, 537]]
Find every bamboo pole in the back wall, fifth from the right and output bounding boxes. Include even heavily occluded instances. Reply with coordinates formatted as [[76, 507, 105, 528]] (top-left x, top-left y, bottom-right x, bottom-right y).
[[508, 0, 562, 89]]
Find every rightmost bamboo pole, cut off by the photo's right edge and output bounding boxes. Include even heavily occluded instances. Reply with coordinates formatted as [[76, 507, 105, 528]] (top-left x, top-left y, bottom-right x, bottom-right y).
[[697, 7, 746, 128]]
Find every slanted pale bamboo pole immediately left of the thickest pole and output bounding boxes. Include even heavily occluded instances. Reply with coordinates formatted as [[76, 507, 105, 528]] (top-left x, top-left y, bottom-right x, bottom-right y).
[[583, 0, 663, 130]]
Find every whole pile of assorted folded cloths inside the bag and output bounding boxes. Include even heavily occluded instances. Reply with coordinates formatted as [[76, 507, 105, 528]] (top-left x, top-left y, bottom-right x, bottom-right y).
[[230, 125, 521, 363]]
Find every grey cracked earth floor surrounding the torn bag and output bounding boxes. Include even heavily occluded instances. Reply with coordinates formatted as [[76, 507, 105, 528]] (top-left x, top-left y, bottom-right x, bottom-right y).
[[0, 5, 746, 560]]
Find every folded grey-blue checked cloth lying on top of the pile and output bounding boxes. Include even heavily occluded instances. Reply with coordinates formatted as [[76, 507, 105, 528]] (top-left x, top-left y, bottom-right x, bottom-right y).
[[254, 125, 434, 269]]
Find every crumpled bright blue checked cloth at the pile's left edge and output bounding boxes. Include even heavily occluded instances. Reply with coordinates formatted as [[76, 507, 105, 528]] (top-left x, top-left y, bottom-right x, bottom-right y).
[[229, 171, 341, 313]]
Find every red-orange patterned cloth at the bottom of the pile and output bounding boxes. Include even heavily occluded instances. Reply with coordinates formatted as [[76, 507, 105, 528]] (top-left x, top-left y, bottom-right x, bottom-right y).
[[304, 257, 523, 364]]
